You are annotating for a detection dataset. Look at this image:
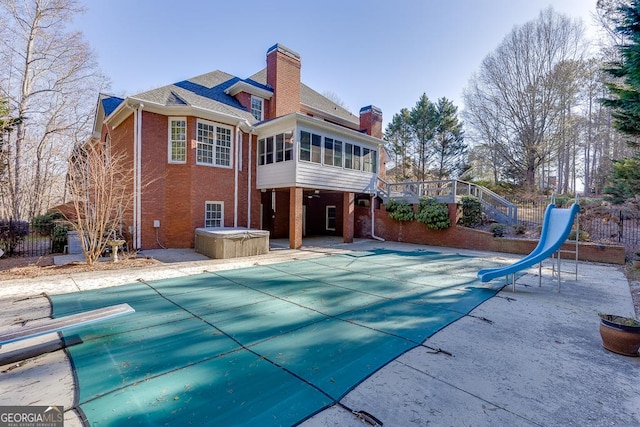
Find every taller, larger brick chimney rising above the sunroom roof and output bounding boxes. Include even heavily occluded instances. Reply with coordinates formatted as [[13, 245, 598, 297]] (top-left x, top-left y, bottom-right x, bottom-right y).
[[265, 44, 300, 119]]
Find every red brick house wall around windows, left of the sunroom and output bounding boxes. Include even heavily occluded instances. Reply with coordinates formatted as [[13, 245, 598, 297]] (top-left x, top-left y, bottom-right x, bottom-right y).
[[106, 111, 260, 249]]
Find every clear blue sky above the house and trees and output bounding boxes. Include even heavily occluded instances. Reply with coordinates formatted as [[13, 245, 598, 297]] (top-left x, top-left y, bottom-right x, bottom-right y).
[[73, 0, 596, 125]]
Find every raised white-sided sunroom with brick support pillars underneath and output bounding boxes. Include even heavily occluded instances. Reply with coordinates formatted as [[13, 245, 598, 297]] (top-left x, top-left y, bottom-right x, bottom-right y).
[[256, 113, 382, 247]]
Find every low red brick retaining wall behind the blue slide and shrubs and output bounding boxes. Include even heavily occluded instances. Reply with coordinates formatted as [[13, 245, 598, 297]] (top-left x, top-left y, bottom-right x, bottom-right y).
[[355, 204, 625, 264]]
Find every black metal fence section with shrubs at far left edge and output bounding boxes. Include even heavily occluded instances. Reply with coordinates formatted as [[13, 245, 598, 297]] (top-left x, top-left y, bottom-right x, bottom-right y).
[[0, 219, 64, 257]]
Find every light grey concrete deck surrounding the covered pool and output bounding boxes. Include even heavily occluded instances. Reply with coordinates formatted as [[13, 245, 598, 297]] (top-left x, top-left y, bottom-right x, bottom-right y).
[[0, 239, 640, 426]]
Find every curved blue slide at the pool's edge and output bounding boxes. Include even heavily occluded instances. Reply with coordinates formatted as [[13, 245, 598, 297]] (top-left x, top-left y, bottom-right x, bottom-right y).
[[478, 203, 580, 282]]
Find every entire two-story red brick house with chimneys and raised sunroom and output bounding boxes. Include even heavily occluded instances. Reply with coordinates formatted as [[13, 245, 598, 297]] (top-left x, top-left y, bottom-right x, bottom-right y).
[[92, 44, 383, 249]]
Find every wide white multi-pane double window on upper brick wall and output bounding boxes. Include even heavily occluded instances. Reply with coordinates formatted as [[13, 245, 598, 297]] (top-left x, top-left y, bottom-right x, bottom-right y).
[[196, 120, 232, 167]]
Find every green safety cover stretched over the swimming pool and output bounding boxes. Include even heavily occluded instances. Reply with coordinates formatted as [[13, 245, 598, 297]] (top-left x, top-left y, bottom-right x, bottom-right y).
[[51, 250, 500, 426]]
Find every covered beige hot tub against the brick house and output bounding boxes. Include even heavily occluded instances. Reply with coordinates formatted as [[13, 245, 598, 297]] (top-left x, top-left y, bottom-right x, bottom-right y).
[[195, 227, 269, 259]]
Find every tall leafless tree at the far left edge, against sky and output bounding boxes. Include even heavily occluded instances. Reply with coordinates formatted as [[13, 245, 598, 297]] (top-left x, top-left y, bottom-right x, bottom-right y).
[[0, 0, 107, 218]]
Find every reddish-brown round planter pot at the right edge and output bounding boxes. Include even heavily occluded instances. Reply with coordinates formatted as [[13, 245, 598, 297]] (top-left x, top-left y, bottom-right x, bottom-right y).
[[598, 313, 640, 357]]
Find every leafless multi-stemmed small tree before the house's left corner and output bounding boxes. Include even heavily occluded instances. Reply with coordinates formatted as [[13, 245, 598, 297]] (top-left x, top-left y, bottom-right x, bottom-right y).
[[67, 141, 133, 264]]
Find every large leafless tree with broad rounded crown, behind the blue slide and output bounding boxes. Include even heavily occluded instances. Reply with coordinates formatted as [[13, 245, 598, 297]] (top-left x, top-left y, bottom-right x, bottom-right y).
[[465, 8, 584, 192]]
